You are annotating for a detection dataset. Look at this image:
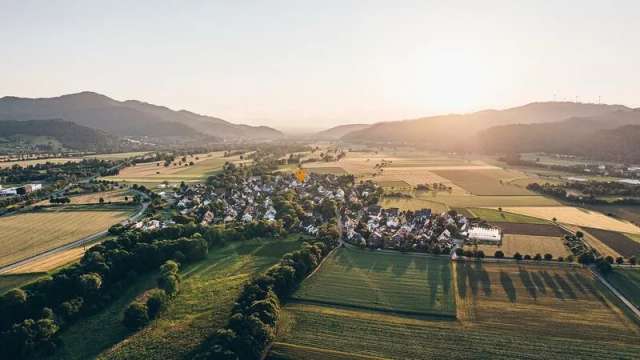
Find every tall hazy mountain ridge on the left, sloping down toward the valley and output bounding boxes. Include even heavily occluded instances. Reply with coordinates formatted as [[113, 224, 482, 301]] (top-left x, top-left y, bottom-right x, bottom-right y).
[[0, 92, 282, 139]]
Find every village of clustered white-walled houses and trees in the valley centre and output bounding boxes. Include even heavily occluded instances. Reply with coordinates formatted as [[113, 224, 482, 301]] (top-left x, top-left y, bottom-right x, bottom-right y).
[[127, 167, 502, 254]]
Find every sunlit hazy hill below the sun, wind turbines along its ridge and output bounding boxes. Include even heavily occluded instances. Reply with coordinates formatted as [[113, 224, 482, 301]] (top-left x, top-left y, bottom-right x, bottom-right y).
[[342, 102, 629, 150]]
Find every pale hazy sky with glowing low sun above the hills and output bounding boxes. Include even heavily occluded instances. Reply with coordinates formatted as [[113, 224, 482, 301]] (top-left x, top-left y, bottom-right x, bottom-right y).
[[0, 0, 640, 129]]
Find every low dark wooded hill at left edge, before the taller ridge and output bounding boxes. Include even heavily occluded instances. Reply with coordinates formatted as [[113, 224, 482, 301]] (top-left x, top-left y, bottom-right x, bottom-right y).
[[0, 119, 120, 151]]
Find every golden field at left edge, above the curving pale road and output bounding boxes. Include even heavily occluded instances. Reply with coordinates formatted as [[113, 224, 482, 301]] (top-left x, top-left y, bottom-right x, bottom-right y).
[[0, 210, 128, 265]]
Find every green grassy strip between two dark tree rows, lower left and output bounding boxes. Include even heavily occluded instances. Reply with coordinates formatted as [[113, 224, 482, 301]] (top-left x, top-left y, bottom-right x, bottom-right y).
[[95, 236, 308, 360]]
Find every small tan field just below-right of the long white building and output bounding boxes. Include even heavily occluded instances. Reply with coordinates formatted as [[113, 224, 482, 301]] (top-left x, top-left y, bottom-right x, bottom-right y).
[[467, 234, 571, 259]]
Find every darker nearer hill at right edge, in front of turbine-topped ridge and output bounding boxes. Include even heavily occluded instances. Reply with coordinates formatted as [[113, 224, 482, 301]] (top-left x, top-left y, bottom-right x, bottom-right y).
[[478, 110, 640, 162]]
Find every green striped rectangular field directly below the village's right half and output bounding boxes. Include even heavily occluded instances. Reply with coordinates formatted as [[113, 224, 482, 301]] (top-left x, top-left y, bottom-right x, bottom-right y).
[[293, 248, 455, 316]]
